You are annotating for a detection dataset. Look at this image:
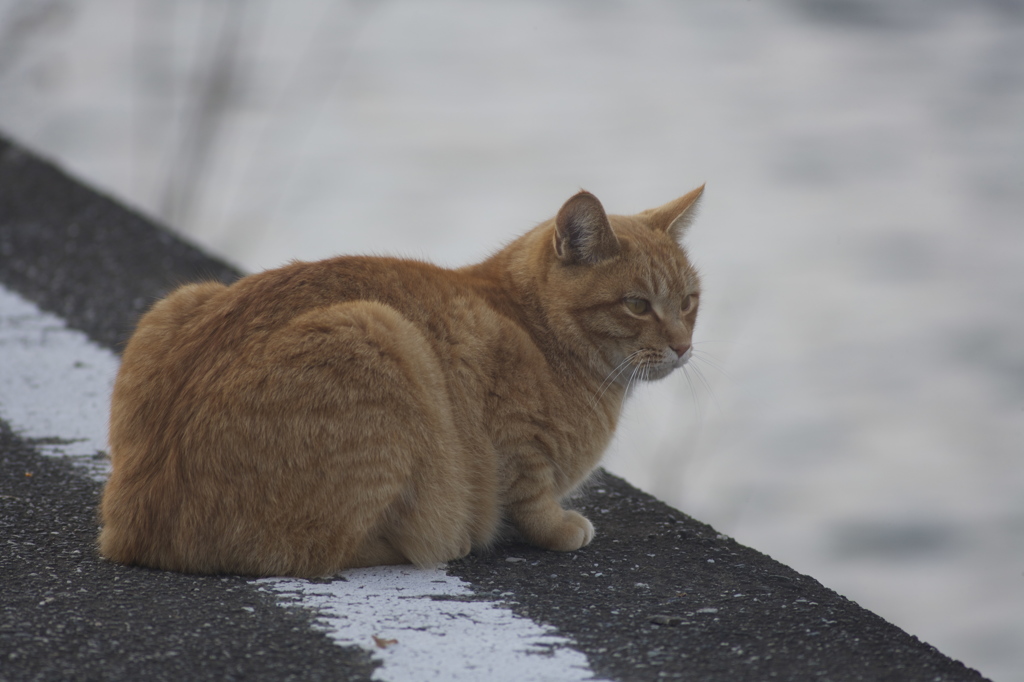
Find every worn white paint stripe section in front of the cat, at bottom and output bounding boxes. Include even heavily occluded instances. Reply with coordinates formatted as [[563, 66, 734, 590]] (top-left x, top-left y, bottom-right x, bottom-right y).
[[260, 566, 595, 682]]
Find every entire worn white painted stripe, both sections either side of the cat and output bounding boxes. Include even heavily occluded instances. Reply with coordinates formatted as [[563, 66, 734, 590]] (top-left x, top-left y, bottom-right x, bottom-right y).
[[0, 286, 595, 682]]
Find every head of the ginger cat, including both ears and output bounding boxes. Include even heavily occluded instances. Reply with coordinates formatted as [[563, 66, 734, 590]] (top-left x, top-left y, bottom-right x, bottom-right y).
[[541, 185, 703, 385]]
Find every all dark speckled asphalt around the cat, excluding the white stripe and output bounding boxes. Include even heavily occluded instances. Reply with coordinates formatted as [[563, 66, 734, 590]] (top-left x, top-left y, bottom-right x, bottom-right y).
[[0, 134, 983, 682]]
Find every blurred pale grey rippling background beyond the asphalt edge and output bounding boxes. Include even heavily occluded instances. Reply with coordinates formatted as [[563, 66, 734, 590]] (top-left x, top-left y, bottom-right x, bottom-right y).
[[0, 0, 1024, 682]]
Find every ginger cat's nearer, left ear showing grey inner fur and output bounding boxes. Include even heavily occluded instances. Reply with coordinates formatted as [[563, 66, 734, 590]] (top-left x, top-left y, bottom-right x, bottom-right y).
[[555, 191, 618, 264]]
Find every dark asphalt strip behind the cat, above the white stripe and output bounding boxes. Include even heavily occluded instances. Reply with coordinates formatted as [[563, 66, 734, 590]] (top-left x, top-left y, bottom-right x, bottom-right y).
[[0, 136, 241, 351]]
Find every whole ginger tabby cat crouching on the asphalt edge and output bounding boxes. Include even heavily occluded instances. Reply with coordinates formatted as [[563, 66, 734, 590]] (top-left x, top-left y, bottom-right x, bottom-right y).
[[99, 186, 703, 577]]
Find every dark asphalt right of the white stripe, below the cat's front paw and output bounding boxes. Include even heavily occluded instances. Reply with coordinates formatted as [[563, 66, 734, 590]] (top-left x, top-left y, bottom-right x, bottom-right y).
[[449, 474, 983, 682]]
